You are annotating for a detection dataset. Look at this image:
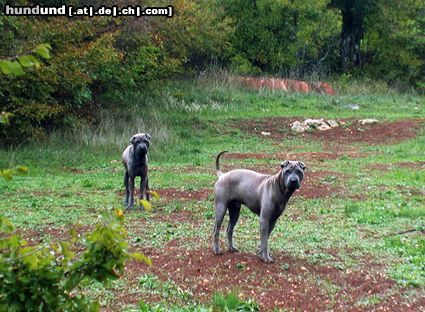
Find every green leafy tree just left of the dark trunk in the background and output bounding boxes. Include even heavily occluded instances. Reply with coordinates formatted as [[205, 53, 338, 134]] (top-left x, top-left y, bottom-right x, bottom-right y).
[[220, 0, 339, 75]]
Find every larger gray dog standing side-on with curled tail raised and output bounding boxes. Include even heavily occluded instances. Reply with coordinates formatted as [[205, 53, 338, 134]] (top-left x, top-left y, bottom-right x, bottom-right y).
[[214, 151, 305, 263]]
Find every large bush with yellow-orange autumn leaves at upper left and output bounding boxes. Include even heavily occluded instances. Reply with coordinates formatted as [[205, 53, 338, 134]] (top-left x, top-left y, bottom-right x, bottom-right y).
[[0, 0, 232, 143]]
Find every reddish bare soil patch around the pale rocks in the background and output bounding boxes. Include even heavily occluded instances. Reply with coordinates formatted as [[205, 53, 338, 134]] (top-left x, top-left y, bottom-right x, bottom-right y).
[[231, 117, 424, 145]]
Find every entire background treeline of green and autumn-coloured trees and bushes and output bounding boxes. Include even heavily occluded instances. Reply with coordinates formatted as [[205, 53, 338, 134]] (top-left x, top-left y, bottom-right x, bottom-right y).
[[0, 0, 425, 143]]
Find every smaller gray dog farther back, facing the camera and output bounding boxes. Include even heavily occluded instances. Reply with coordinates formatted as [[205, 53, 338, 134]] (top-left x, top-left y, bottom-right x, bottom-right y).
[[122, 133, 151, 209]]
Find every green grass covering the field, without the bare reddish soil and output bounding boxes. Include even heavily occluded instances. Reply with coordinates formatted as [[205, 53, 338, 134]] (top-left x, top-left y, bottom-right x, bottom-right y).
[[0, 75, 425, 311]]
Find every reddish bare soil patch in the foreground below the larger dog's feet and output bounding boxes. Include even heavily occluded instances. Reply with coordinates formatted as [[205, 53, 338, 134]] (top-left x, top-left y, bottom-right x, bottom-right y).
[[108, 243, 423, 311]]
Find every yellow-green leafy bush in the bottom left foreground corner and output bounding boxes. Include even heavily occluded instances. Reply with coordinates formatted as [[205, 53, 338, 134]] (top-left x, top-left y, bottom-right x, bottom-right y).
[[0, 210, 150, 311]]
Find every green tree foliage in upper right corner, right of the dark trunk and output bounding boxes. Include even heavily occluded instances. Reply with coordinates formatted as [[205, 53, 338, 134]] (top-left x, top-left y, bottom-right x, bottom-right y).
[[362, 0, 425, 86]]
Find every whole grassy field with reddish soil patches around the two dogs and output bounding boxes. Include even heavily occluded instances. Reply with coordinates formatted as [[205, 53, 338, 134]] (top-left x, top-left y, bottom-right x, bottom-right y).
[[0, 78, 425, 311]]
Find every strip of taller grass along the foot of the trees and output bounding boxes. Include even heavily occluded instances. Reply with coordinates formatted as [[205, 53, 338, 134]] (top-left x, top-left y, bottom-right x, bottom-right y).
[[0, 69, 425, 168]]
